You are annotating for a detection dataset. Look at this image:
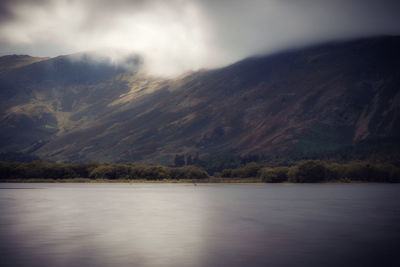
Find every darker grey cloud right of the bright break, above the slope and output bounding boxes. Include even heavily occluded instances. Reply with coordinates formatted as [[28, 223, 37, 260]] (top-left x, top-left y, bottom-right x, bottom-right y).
[[201, 0, 400, 56]]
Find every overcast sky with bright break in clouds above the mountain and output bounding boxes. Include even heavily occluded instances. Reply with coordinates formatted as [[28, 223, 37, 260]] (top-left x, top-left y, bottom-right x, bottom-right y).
[[0, 0, 400, 76]]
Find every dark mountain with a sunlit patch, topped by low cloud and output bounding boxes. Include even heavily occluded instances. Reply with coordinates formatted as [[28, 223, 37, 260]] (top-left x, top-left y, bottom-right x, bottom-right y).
[[0, 36, 400, 168]]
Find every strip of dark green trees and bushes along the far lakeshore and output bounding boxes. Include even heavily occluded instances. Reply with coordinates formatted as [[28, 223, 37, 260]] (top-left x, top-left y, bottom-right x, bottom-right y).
[[0, 160, 400, 183]]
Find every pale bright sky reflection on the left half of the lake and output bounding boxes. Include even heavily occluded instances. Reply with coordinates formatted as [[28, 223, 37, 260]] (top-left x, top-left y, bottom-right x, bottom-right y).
[[1, 185, 203, 266]]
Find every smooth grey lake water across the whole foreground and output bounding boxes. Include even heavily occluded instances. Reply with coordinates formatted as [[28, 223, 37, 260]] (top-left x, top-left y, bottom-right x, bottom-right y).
[[0, 184, 400, 267]]
